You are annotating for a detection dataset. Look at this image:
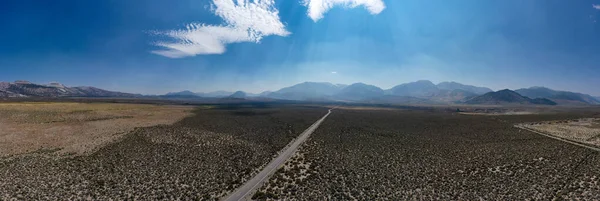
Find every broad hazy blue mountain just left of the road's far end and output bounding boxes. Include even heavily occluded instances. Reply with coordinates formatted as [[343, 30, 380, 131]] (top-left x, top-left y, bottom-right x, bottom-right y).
[[268, 82, 344, 100]]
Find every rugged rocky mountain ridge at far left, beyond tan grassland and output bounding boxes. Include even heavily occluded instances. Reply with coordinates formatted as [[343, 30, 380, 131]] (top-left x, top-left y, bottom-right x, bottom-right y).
[[0, 80, 141, 97]]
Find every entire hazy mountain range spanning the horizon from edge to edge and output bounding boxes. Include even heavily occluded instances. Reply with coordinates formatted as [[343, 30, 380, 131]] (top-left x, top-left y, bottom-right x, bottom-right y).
[[0, 80, 600, 105]]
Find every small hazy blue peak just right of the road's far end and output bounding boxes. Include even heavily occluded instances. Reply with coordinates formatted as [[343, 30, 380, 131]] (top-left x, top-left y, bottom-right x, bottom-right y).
[[334, 83, 384, 101]]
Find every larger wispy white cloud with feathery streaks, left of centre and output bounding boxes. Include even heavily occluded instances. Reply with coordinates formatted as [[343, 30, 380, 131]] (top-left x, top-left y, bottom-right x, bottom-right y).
[[152, 0, 290, 58]]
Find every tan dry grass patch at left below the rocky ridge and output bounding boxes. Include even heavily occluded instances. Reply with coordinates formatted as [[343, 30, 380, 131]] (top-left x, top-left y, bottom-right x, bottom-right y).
[[0, 102, 192, 156]]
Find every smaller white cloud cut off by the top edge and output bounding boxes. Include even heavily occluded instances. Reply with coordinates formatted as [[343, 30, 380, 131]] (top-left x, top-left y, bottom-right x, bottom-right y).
[[303, 0, 385, 22]]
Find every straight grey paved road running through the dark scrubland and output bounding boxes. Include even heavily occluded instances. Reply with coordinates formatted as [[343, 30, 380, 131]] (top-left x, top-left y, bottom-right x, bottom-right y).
[[225, 109, 331, 201]]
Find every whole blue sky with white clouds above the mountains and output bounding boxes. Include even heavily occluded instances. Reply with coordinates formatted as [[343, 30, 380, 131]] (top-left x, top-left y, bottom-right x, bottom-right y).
[[0, 0, 600, 96]]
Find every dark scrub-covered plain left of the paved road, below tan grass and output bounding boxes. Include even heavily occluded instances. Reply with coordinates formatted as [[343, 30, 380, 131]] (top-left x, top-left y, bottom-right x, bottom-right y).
[[0, 105, 327, 200]]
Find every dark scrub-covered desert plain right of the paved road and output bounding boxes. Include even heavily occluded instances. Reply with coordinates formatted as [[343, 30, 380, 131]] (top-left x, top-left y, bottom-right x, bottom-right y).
[[254, 110, 600, 200]]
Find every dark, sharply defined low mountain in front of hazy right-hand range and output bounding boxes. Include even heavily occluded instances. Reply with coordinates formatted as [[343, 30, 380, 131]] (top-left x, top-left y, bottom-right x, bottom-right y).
[[465, 89, 556, 105]]
